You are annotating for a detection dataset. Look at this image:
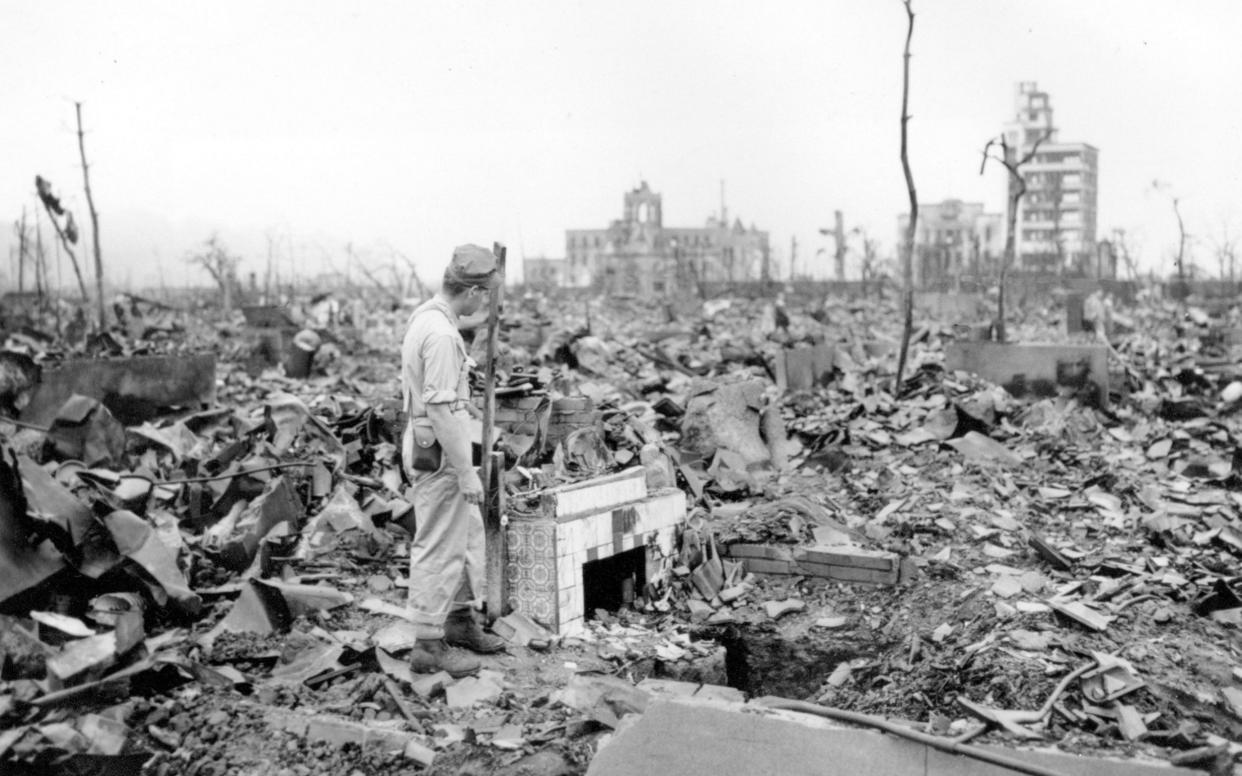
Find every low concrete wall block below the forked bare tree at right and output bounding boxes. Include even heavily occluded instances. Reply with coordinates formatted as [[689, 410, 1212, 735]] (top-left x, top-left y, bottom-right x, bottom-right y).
[[944, 343, 1108, 407]]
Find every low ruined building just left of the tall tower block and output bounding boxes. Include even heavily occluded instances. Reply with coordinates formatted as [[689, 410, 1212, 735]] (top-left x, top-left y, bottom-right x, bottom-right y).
[[897, 200, 1005, 288]]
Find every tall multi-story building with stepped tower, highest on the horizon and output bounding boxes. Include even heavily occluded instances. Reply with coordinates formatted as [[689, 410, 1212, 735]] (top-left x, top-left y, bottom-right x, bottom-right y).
[[1005, 81, 1099, 274]]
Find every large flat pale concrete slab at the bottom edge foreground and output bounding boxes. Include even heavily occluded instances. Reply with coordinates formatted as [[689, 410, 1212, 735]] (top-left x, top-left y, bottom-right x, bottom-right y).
[[586, 700, 1196, 776]]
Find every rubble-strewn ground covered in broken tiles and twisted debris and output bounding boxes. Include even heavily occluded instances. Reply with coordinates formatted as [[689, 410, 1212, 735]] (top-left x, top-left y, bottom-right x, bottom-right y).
[[0, 285, 1242, 776]]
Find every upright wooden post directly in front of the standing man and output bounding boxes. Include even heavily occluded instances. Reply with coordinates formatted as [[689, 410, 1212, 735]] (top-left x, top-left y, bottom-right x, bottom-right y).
[[473, 242, 507, 621]]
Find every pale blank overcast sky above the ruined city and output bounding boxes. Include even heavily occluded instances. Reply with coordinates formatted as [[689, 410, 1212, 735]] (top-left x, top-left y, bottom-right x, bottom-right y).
[[0, 0, 1242, 287]]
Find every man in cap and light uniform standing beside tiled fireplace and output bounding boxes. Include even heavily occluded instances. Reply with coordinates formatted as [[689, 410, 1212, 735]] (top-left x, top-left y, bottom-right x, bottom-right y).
[[401, 245, 504, 677]]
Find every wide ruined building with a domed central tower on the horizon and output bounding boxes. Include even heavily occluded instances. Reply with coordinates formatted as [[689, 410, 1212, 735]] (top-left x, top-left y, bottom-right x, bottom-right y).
[[565, 181, 769, 296]]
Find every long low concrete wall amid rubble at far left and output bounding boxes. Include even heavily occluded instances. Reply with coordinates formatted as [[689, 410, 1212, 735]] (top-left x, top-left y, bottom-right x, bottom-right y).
[[21, 353, 216, 426]]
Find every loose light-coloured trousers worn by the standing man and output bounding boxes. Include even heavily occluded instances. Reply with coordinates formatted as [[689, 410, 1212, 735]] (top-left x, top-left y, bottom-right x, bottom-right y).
[[407, 461, 487, 638]]
